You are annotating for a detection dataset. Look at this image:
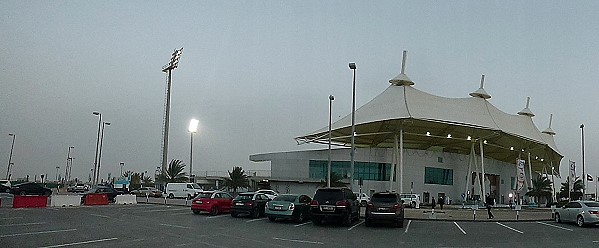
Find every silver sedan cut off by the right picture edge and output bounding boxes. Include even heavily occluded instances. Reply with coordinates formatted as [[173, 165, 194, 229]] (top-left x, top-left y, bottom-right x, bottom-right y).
[[554, 201, 599, 227]]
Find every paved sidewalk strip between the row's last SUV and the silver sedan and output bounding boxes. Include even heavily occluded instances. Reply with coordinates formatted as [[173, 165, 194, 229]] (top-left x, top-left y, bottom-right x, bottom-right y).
[[405, 206, 553, 221]]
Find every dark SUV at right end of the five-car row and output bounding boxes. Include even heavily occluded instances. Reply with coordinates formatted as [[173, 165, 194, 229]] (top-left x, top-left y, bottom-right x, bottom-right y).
[[364, 192, 404, 227]]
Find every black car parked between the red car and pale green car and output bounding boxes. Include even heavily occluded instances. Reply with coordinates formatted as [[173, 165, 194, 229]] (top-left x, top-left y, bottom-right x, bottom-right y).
[[231, 192, 270, 218]]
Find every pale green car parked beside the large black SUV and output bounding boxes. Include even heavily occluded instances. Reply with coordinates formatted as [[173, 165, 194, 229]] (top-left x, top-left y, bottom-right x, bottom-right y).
[[264, 194, 312, 223]]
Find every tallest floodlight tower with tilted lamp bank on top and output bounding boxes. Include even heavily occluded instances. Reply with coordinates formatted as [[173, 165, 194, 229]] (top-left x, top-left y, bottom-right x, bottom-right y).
[[162, 48, 183, 170]]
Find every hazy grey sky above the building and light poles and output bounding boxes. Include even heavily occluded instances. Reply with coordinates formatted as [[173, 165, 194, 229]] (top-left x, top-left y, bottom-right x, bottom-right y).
[[0, 0, 599, 184]]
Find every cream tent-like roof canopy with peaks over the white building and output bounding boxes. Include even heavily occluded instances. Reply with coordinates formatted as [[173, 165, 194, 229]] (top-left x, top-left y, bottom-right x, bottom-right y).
[[295, 77, 563, 174]]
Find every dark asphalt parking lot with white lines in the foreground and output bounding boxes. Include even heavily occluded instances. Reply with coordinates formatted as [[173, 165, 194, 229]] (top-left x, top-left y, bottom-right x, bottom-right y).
[[0, 204, 599, 247]]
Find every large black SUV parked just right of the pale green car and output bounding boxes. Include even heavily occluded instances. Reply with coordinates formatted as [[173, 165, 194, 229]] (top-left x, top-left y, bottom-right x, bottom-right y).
[[310, 188, 360, 226]]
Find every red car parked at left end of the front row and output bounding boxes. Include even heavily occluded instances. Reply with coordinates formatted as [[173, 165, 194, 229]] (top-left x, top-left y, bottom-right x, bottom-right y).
[[191, 191, 233, 215]]
